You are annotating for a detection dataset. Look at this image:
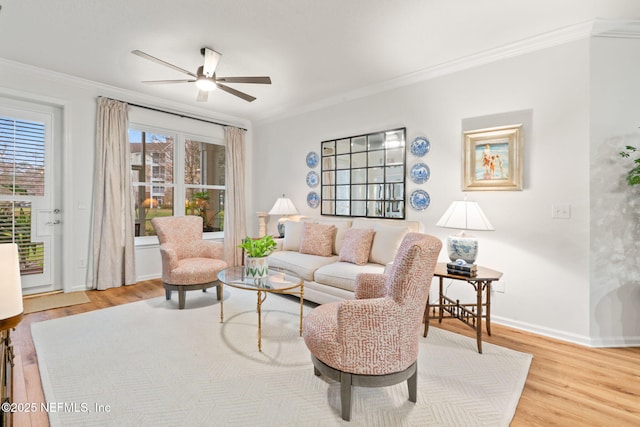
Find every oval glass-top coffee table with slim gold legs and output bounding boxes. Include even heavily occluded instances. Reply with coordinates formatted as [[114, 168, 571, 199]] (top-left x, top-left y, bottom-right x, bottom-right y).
[[218, 267, 304, 351]]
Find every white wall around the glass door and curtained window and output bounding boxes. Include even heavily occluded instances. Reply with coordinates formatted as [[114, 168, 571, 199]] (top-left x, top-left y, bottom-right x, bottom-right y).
[[0, 59, 251, 292]]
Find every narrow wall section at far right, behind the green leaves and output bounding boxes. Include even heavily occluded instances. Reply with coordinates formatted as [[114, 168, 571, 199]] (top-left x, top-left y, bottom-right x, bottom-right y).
[[589, 37, 640, 345]]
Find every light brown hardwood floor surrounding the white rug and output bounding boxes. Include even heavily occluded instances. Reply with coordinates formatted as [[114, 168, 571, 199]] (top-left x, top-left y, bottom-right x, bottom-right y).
[[6, 280, 640, 427]]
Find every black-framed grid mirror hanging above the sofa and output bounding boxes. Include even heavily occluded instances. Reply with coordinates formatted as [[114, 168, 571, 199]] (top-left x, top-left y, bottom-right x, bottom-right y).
[[320, 128, 406, 219]]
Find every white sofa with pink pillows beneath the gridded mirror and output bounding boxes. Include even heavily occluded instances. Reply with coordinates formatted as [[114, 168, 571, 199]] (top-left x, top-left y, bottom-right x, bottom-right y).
[[269, 218, 422, 304]]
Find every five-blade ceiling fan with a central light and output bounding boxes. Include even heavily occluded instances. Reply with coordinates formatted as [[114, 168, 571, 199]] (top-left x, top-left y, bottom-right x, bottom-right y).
[[131, 47, 271, 102]]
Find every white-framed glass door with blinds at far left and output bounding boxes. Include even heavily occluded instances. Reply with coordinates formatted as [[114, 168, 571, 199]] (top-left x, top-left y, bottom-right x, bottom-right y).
[[0, 103, 62, 294]]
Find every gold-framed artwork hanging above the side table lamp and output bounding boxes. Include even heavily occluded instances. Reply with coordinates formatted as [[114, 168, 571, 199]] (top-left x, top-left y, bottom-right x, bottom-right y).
[[462, 124, 522, 191]]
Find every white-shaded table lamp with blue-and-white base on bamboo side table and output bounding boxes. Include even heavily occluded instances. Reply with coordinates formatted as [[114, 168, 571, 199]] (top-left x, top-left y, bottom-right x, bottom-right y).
[[436, 198, 495, 264]]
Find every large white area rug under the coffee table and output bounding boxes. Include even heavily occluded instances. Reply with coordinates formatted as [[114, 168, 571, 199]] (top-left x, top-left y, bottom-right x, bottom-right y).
[[32, 287, 531, 426]]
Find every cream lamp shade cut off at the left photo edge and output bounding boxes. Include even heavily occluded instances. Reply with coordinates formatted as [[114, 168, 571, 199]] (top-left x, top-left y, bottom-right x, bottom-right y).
[[0, 243, 23, 320]]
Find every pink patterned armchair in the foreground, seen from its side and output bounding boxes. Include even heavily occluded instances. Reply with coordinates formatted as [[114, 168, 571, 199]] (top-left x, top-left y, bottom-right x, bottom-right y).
[[304, 233, 442, 421]]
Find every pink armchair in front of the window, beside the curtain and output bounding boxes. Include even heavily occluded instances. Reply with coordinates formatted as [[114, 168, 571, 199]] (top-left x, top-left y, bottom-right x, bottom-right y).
[[151, 216, 227, 309]]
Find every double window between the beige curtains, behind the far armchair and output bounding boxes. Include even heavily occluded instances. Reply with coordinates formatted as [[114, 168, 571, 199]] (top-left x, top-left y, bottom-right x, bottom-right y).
[[129, 126, 225, 236]]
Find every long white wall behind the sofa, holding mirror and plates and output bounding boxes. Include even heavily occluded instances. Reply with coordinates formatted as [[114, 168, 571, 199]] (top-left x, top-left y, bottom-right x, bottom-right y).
[[253, 38, 604, 344]]
